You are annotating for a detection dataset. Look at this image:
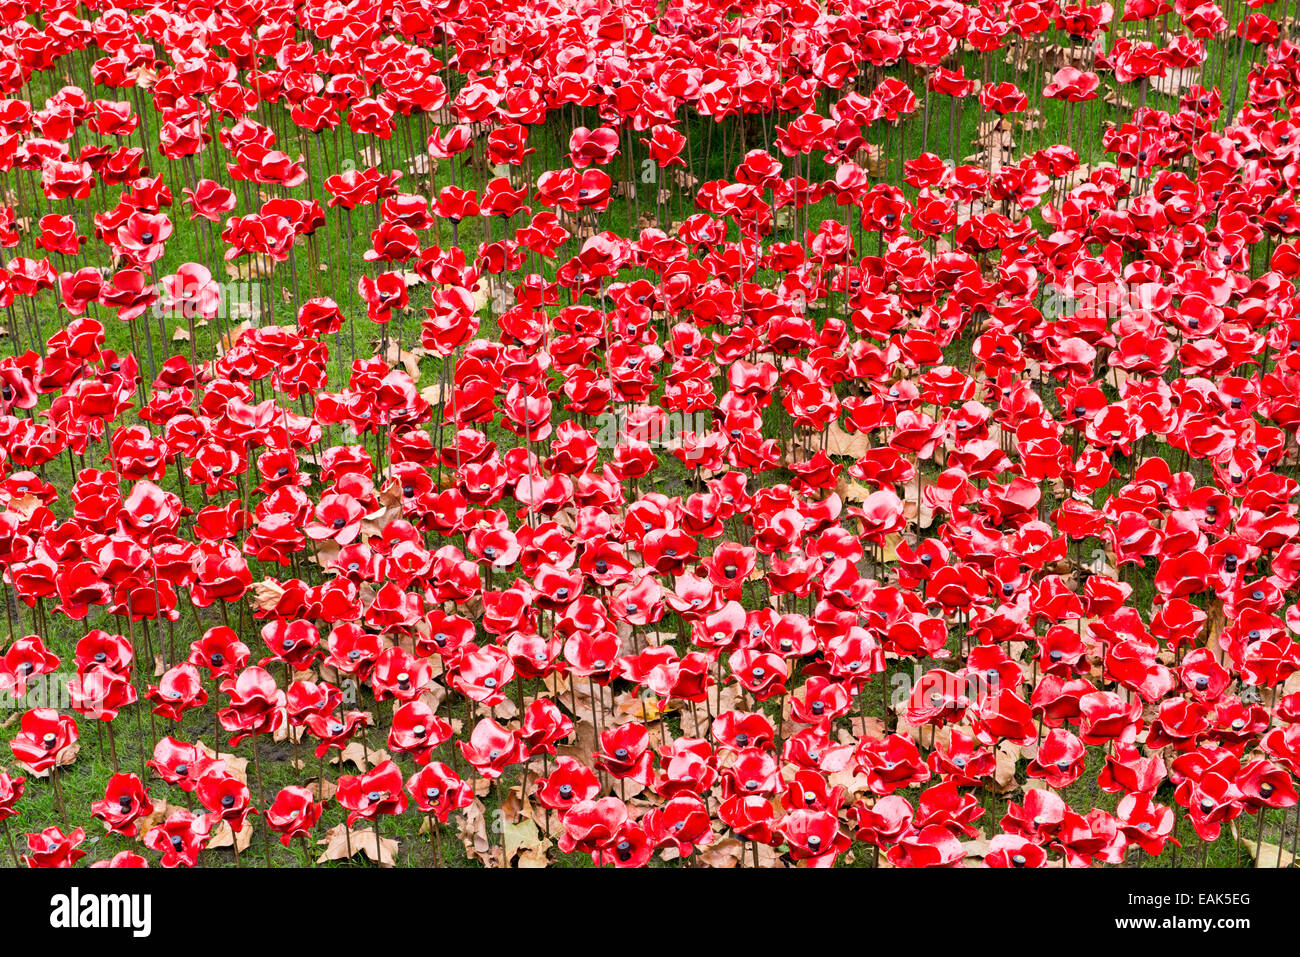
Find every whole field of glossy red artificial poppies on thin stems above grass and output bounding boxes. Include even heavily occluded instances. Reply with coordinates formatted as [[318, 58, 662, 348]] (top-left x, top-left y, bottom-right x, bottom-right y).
[[0, 0, 1300, 866]]
